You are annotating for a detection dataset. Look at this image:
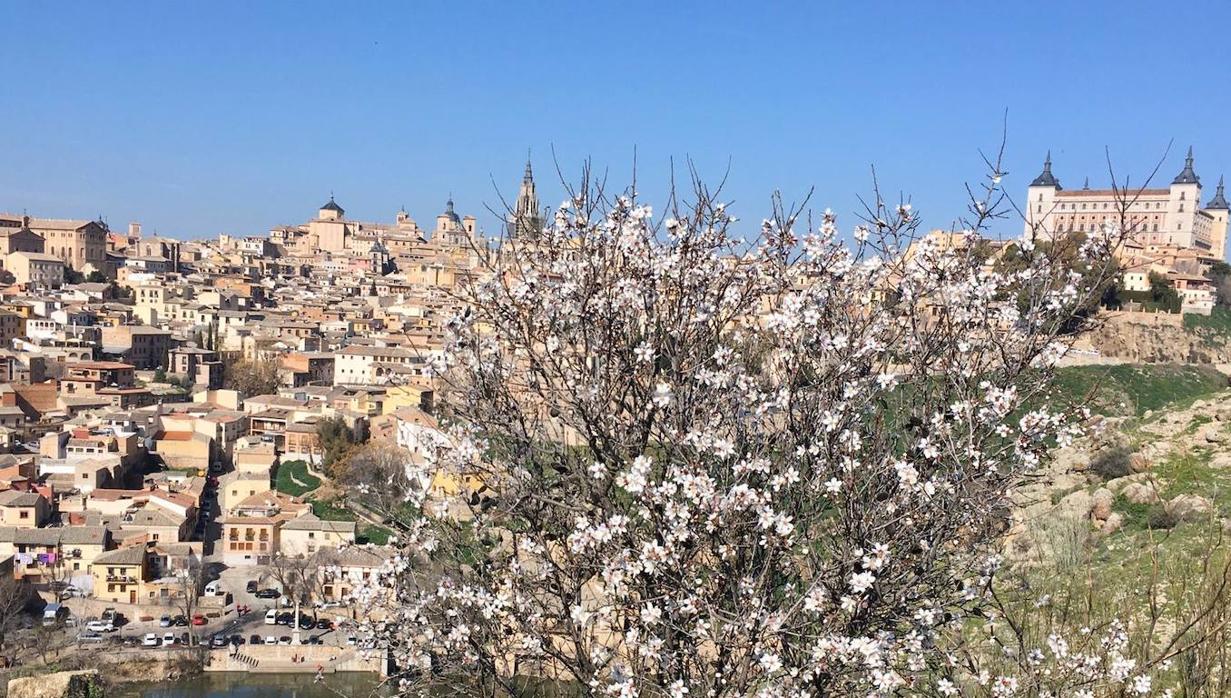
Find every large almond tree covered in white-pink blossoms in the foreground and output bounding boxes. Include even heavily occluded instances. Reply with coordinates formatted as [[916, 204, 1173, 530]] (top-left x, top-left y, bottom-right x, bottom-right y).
[[356, 155, 1171, 698]]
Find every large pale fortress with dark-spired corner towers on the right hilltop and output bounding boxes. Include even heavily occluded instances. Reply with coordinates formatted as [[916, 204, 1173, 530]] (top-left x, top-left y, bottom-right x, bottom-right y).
[[1025, 148, 1229, 261]]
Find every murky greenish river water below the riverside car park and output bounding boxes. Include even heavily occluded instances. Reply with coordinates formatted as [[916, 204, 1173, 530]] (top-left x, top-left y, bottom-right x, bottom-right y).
[[107, 672, 389, 698]]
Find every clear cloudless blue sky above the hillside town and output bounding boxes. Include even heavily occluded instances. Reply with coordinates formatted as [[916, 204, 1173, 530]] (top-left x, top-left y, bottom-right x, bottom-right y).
[[0, 0, 1231, 236]]
